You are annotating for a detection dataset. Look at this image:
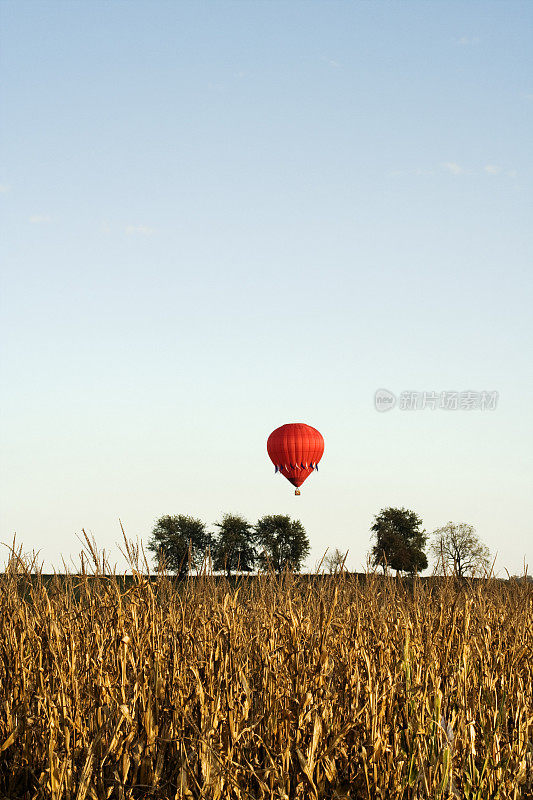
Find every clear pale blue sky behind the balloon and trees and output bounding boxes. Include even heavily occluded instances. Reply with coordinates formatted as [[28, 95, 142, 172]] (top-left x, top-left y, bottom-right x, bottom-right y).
[[0, 0, 533, 573]]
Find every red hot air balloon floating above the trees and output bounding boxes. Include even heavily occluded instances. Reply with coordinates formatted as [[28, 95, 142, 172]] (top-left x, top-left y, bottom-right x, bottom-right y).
[[267, 422, 324, 494]]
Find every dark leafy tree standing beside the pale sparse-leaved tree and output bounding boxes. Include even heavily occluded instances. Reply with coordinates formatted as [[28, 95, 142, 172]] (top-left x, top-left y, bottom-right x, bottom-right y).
[[371, 508, 428, 574]]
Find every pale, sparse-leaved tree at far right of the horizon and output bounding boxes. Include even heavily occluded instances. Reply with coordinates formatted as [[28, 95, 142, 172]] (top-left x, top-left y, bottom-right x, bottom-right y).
[[431, 522, 490, 578]]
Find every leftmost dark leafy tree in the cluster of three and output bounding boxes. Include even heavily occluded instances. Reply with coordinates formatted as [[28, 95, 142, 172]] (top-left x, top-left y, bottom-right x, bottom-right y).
[[148, 514, 209, 578]]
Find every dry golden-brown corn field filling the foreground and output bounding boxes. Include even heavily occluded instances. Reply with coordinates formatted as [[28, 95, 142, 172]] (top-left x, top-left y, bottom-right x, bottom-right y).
[[0, 548, 533, 800]]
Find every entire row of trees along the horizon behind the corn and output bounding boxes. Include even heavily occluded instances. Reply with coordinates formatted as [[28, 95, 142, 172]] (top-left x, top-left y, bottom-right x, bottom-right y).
[[148, 507, 490, 578]]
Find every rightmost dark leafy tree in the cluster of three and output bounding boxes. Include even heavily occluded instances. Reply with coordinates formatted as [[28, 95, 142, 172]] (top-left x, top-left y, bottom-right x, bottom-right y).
[[255, 514, 310, 572]]
